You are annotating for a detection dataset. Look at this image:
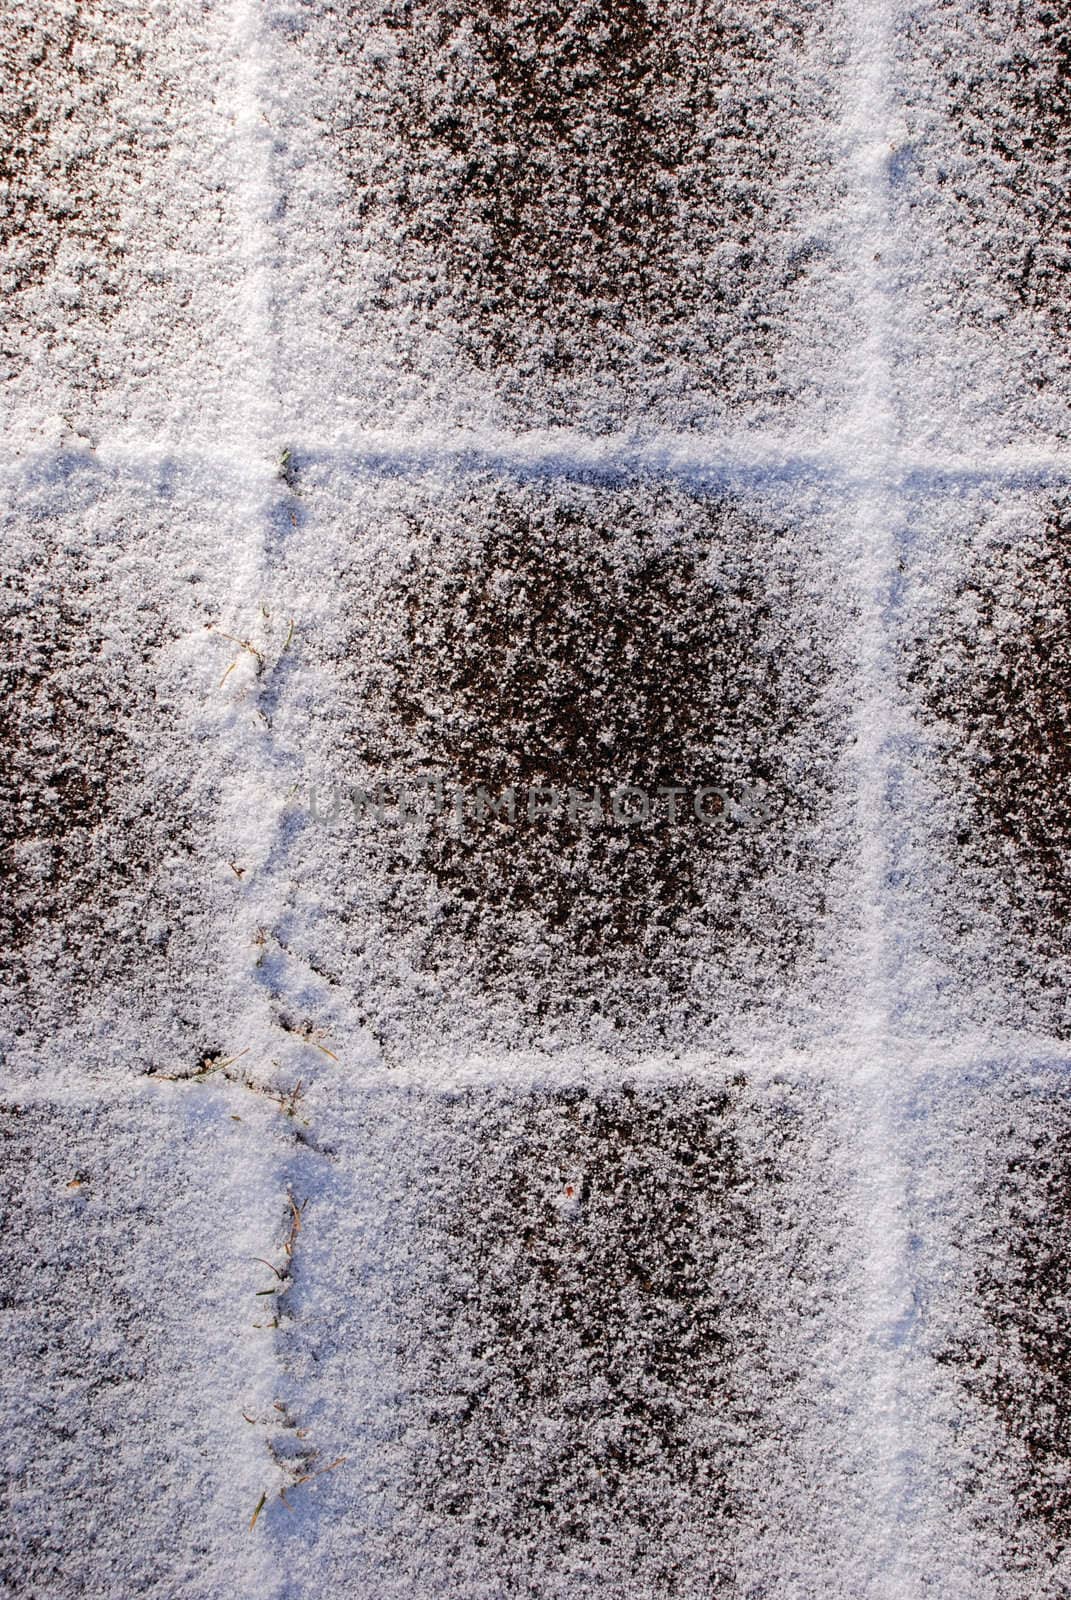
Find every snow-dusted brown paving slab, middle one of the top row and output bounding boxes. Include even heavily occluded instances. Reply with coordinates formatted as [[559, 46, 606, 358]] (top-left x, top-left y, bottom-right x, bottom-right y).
[[261, 0, 845, 434]]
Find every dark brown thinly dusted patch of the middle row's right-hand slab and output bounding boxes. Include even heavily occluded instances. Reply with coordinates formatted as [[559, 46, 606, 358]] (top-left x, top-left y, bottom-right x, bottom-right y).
[[909, 498, 1071, 1027]]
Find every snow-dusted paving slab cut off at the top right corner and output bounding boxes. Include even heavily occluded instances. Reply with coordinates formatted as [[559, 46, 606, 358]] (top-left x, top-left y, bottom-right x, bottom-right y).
[[890, 0, 1071, 448]]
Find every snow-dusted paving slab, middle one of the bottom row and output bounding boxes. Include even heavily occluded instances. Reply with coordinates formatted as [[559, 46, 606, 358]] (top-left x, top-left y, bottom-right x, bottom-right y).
[[248, 1066, 861, 1597]]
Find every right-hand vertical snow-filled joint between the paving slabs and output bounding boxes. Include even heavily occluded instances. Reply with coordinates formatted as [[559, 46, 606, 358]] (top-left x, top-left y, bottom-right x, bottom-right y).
[[845, 0, 928, 1600]]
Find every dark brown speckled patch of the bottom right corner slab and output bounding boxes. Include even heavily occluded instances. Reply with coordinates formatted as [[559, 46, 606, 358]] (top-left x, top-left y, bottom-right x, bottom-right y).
[[935, 1069, 1071, 1595]]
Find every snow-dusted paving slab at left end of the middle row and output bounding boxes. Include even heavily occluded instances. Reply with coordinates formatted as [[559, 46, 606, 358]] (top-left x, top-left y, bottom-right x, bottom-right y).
[[0, 446, 283, 1078]]
